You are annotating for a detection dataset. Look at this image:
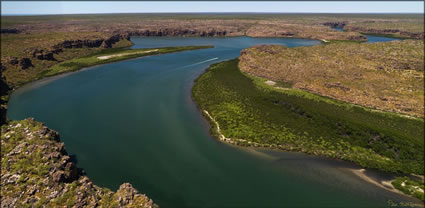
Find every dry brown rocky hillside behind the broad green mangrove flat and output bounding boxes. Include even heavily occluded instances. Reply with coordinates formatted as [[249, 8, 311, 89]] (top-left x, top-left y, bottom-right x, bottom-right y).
[[239, 40, 424, 117]]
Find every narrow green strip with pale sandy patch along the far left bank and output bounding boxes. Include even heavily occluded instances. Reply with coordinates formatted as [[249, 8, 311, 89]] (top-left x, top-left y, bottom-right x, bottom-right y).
[[38, 46, 213, 78]]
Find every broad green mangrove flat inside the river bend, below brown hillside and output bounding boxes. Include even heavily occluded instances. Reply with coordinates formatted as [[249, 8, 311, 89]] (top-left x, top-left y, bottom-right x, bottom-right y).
[[192, 60, 424, 175]]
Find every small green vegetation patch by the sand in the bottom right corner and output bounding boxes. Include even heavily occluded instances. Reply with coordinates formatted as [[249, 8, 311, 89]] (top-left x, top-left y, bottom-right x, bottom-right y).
[[392, 177, 425, 201]]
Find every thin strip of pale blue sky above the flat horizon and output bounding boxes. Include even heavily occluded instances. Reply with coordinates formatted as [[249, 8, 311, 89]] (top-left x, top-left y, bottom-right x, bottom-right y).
[[1, 1, 424, 15]]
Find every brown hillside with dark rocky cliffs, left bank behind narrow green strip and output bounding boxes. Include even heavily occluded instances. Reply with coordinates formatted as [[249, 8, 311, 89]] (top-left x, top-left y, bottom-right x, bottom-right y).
[[1, 31, 132, 88]]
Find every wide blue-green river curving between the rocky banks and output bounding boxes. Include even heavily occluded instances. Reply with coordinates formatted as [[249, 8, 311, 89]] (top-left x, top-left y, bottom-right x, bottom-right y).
[[8, 37, 409, 208]]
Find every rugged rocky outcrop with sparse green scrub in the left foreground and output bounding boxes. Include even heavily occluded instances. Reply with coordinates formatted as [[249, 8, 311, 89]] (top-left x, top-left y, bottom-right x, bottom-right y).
[[1, 119, 158, 208]]
